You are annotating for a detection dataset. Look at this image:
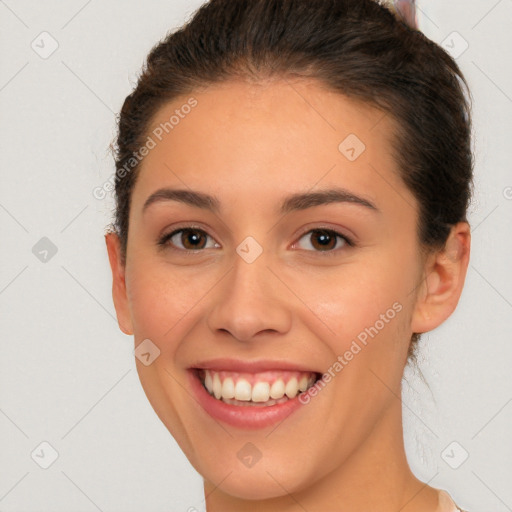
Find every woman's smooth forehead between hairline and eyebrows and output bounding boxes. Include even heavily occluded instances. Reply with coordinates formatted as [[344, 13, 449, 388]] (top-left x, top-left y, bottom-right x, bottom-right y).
[[134, 79, 407, 216]]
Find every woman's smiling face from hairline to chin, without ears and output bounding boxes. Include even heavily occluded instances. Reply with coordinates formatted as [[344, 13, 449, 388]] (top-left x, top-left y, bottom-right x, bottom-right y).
[[110, 80, 430, 499]]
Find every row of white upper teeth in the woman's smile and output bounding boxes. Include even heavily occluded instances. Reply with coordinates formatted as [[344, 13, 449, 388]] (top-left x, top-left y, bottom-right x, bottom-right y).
[[204, 370, 315, 402]]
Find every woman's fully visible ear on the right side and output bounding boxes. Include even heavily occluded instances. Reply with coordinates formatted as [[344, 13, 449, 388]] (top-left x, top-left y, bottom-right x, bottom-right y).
[[411, 222, 471, 333]]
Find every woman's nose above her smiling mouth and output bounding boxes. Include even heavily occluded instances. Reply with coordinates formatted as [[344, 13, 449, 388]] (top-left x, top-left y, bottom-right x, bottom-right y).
[[207, 252, 292, 342]]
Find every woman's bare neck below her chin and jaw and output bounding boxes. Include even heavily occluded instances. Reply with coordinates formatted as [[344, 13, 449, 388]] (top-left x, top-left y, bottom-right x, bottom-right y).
[[204, 399, 438, 512]]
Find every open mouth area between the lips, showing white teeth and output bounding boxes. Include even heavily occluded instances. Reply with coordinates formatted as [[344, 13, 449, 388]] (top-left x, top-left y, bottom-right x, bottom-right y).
[[192, 368, 321, 407]]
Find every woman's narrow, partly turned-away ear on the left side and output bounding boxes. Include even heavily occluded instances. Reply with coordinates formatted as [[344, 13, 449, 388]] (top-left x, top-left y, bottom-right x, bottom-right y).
[[105, 233, 133, 335]]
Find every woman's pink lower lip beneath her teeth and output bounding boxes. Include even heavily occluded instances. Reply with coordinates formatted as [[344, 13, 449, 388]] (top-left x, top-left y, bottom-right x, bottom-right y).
[[188, 370, 312, 429]]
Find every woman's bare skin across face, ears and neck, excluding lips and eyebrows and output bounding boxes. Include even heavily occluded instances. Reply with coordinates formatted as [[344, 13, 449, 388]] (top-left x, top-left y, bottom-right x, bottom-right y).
[[106, 79, 470, 512]]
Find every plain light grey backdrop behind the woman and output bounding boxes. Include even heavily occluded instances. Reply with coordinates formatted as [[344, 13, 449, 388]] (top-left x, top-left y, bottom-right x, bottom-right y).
[[0, 0, 512, 512]]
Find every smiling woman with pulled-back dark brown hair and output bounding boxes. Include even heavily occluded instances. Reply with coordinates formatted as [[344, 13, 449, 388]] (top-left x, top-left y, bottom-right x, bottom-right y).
[[106, 0, 473, 512]]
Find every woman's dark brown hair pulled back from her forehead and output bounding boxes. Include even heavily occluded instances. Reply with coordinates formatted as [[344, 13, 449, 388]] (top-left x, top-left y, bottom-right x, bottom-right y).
[[110, 0, 473, 353]]
